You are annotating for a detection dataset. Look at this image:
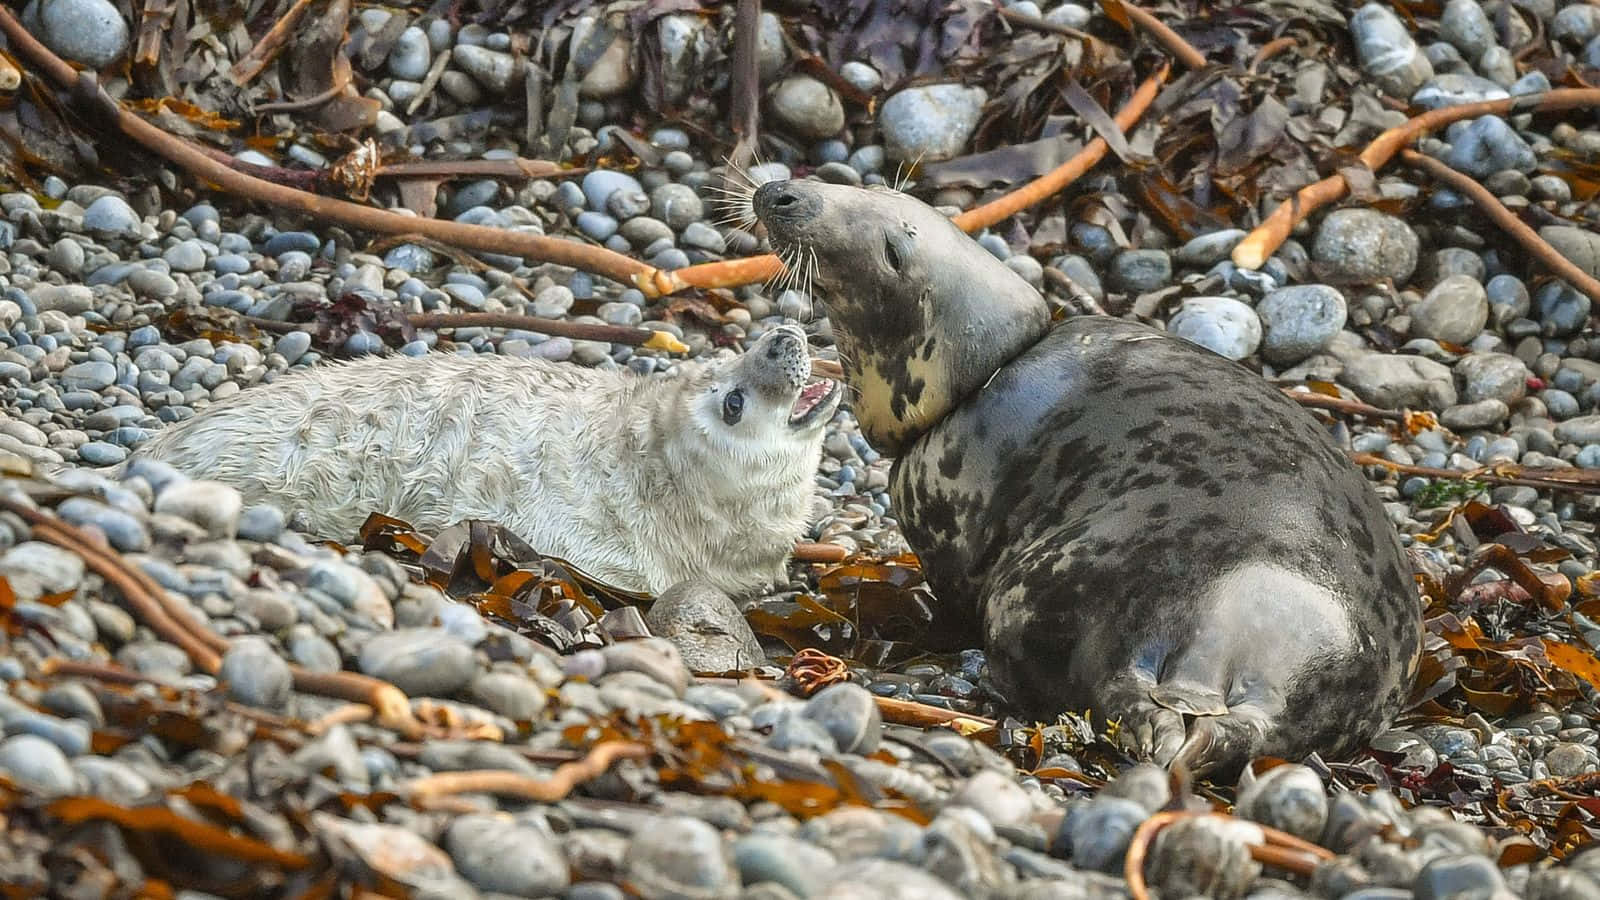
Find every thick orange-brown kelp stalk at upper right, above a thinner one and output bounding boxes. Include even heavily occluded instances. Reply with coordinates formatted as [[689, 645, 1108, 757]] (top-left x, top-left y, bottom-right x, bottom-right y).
[[1232, 88, 1600, 269]]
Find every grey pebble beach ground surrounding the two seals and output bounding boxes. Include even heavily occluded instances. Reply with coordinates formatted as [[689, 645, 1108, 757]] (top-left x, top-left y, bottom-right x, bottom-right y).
[[0, 0, 1600, 900]]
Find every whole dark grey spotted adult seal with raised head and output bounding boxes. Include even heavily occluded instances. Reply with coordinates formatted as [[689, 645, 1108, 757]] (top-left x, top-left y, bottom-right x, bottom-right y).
[[752, 181, 1421, 777]]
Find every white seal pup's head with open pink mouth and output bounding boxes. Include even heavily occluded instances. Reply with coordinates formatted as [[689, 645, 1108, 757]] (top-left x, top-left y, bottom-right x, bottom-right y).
[[686, 318, 843, 464]]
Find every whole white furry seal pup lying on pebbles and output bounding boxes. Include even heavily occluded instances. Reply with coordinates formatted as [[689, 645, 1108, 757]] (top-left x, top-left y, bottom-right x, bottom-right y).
[[134, 325, 842, 594]]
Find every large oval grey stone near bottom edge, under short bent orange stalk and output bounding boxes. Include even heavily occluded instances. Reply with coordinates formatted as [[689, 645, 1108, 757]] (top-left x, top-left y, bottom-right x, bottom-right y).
[[442, 815, 571, 897]]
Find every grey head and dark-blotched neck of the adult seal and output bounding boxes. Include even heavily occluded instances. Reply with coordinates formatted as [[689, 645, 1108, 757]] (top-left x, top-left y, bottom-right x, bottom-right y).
[[750, 181, 1050, 455]]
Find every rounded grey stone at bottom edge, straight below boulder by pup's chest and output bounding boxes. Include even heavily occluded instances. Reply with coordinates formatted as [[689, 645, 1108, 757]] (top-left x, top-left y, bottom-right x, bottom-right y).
[[622, 817, 739, 898]]
